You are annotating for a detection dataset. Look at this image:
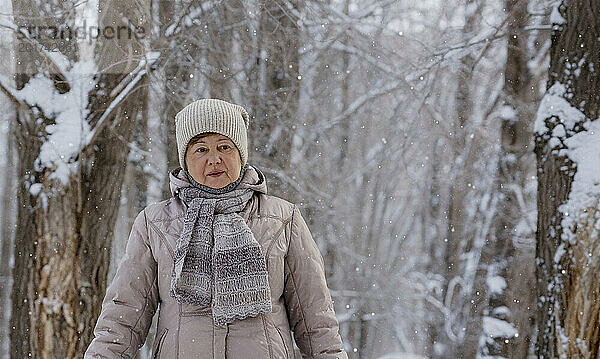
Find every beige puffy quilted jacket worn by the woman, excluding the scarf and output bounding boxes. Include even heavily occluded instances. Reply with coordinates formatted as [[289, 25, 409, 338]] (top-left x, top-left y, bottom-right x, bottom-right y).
[[84, 167, 347, 359]]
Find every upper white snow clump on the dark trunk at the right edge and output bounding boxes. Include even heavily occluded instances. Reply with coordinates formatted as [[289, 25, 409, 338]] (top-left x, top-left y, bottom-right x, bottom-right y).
[[534, 82, 585, 135]]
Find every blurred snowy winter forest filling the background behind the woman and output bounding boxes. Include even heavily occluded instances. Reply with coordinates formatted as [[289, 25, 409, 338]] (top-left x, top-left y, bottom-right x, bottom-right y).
[[0, 0, 600, 359]]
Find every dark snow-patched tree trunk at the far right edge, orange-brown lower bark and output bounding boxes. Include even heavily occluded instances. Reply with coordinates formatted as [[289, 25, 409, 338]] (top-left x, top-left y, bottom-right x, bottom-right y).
[[535, 0, 600, 358]]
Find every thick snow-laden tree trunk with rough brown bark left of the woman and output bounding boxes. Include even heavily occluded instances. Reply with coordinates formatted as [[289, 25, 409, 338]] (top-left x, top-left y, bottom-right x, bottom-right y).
[[0, 1, 156, 359]]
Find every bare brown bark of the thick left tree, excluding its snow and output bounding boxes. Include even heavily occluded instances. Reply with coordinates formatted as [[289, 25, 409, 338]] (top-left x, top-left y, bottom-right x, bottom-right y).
[[11, 1, 147, 359]]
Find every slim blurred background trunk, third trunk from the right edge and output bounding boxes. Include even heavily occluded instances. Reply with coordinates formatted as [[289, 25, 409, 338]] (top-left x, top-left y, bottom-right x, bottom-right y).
[[442, 0, 487, 358]]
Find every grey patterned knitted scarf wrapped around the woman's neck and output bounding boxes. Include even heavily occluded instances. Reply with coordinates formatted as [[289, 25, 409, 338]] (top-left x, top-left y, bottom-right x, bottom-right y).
[[170, 168, 272, 326]]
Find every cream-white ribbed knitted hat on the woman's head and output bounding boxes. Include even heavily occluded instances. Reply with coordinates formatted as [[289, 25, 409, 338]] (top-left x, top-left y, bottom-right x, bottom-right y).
[[175, 99, 248, 169]]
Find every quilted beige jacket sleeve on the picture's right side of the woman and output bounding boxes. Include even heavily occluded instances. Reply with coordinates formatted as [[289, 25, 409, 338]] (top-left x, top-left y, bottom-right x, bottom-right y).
[[284, 206, 348, 359]]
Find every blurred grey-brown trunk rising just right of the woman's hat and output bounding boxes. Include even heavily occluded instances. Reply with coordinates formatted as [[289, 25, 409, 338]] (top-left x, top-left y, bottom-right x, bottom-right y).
[[249, 1, 301, 200]]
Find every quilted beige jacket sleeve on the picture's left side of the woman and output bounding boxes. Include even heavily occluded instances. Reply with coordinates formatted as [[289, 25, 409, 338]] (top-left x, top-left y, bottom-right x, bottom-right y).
[[84, 211, 158, 359]]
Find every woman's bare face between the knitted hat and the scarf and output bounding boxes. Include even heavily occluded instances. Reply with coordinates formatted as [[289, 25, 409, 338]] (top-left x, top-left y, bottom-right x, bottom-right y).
[[185, 134, 242, 188]]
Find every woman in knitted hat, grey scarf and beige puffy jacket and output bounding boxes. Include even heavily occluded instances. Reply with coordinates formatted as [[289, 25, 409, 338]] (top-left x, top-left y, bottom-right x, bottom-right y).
[[85, 99, 347, 359]]
